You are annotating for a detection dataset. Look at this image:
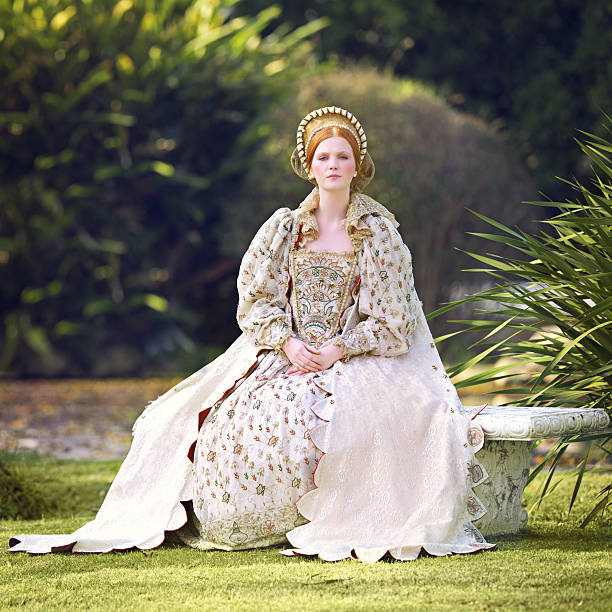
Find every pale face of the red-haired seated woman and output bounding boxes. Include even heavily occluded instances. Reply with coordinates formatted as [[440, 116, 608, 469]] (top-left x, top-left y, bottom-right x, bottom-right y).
[[310, 136, 356, 191]]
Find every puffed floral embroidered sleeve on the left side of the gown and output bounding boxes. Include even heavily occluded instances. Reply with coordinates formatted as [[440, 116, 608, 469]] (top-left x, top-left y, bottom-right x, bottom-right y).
[[236, 208, 294, 352]]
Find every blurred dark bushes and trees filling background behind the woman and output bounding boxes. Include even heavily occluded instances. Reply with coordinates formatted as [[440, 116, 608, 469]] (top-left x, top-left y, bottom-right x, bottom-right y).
[[0, 0, 612, 377]]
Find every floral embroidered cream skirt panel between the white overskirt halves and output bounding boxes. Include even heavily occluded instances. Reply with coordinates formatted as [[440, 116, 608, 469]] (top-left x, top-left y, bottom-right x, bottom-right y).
[[178, 353, 328, 550]]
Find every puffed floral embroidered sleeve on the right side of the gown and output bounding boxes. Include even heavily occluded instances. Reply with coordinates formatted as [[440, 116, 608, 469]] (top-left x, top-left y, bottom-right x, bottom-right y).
[[334, 217, 419, 359]]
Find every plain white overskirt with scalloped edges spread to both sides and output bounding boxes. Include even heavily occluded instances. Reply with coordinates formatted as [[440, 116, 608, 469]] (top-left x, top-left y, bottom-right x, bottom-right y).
[[10, 310, 494, 562]]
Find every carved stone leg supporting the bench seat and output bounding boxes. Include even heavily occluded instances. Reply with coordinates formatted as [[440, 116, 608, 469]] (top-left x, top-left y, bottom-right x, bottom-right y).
[[474, 440, 531, 536]]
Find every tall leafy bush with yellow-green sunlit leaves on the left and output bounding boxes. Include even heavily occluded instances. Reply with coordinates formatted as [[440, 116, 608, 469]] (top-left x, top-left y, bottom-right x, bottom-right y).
[[0, 0, 323, 375]]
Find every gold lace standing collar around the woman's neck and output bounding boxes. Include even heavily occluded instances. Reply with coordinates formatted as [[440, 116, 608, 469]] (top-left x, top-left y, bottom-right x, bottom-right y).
[[293, 188, 399, 252]]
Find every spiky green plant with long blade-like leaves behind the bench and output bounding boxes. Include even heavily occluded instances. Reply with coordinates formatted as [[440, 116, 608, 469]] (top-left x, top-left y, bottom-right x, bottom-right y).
[[429, 116, 612, 525]]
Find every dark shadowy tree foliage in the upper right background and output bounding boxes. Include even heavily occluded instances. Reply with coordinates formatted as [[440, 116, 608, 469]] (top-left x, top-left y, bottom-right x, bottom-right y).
[[242, 0, 612, 198]]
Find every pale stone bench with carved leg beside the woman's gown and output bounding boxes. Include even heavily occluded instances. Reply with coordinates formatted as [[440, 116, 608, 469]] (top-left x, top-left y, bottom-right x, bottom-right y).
[[465, 406, 610, 536]]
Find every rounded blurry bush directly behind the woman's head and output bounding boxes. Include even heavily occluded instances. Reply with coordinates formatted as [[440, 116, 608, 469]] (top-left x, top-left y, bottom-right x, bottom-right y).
[[223, 66, 534, 340]]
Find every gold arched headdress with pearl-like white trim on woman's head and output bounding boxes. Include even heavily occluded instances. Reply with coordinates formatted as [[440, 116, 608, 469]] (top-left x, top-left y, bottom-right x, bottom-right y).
[[291, 106, 374, 191]]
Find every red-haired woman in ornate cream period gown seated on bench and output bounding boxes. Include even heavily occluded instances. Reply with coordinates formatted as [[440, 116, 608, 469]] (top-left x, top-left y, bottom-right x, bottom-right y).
[[10, 107, 494, 561]]
